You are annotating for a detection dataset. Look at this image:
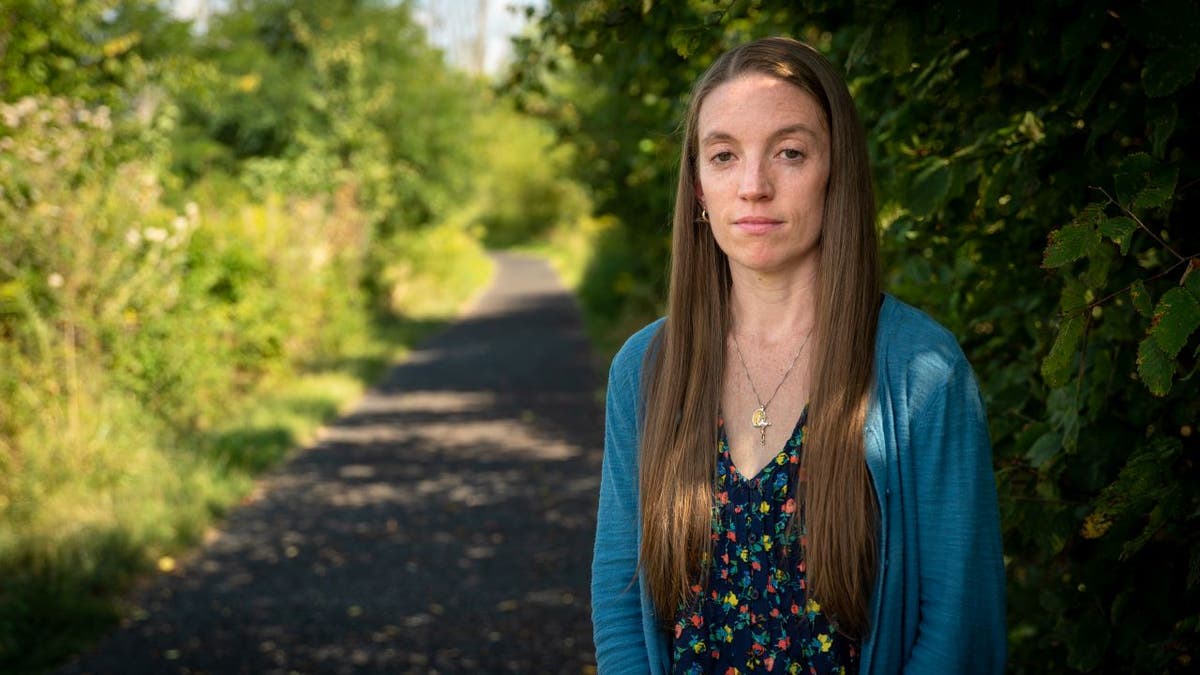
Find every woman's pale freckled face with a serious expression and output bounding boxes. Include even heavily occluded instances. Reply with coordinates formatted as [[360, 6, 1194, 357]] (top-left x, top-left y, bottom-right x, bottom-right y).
[[696, 73, 829, 279]]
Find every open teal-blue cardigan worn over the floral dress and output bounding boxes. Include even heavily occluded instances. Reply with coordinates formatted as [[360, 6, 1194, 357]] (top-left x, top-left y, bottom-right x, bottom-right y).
[[592, 295, 1006, 675]]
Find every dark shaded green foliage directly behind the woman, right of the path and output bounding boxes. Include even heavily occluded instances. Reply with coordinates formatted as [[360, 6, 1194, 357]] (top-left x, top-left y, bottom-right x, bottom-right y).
[[509, 0, 1200, 673]]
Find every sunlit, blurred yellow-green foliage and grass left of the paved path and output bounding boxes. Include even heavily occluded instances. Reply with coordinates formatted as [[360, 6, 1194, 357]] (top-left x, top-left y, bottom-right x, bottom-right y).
[[0, 0, 506, 671]]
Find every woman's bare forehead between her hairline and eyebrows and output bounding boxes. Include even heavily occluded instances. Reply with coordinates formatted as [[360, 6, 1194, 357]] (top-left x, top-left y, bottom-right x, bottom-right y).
[[696, 73, 828, 139]]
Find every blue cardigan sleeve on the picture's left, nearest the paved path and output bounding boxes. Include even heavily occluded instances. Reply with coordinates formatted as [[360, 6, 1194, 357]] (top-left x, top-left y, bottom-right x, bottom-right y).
[[592, 345, 650, 675]]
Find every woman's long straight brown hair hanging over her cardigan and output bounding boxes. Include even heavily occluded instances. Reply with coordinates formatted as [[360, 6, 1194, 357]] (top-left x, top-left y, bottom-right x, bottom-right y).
[[640, 37, 881, 635]]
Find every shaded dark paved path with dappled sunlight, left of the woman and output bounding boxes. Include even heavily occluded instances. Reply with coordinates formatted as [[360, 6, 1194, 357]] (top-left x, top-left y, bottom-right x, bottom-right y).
[[62, 255, 602, 674]]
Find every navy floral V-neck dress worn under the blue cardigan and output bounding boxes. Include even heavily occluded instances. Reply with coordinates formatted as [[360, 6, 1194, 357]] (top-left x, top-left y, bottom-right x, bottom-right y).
[[672, 407, 858, 675]]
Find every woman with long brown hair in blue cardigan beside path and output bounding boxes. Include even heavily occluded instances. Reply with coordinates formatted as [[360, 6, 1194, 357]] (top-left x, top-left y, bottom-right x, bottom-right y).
[[592, 38, 1004, 675]]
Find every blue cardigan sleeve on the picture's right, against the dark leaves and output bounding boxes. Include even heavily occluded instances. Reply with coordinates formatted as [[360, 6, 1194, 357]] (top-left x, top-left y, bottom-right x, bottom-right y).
[[905, 358, 1006, 674]]
